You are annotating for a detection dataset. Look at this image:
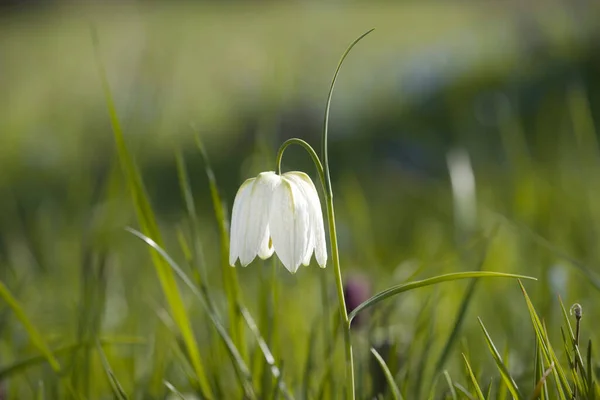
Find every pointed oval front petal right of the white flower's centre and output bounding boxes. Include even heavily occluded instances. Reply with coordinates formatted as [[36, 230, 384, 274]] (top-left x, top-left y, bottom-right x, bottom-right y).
[[269, 177, 310, 273]]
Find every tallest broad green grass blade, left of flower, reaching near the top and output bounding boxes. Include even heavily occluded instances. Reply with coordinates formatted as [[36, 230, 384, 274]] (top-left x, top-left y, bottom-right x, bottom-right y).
[[92, 27, 214, 399]]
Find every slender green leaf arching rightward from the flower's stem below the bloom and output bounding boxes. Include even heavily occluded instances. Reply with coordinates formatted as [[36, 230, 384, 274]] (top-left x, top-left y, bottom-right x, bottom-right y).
[[348, 271, 537, 320]]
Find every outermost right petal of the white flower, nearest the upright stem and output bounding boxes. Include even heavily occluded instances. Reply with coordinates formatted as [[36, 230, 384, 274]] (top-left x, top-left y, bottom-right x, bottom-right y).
[[284, 172, 327, 268]]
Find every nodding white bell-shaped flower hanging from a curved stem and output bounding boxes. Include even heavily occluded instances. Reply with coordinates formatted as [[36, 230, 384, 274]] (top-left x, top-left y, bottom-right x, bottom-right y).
[[229, 172, 327, 273]]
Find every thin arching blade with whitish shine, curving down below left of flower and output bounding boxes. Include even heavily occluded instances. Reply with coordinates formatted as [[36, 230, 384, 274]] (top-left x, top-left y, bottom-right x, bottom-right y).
[[126, 228, 254, 398]]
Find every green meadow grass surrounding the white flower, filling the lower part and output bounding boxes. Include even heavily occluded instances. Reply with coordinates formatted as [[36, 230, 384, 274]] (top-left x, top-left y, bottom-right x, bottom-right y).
[[0, 1, 600, 400]]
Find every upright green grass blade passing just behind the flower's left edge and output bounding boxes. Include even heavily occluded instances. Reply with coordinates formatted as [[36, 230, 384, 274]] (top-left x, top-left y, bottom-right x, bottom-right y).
[[195, 133, 248, 360]]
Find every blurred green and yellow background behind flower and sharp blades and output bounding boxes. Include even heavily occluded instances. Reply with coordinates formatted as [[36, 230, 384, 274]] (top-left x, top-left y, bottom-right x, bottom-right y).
[[0, 1, 600, 399]]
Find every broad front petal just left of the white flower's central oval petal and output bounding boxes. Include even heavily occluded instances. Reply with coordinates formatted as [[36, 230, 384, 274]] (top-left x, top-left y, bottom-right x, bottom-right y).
[[240, 172, 281, 266]]
